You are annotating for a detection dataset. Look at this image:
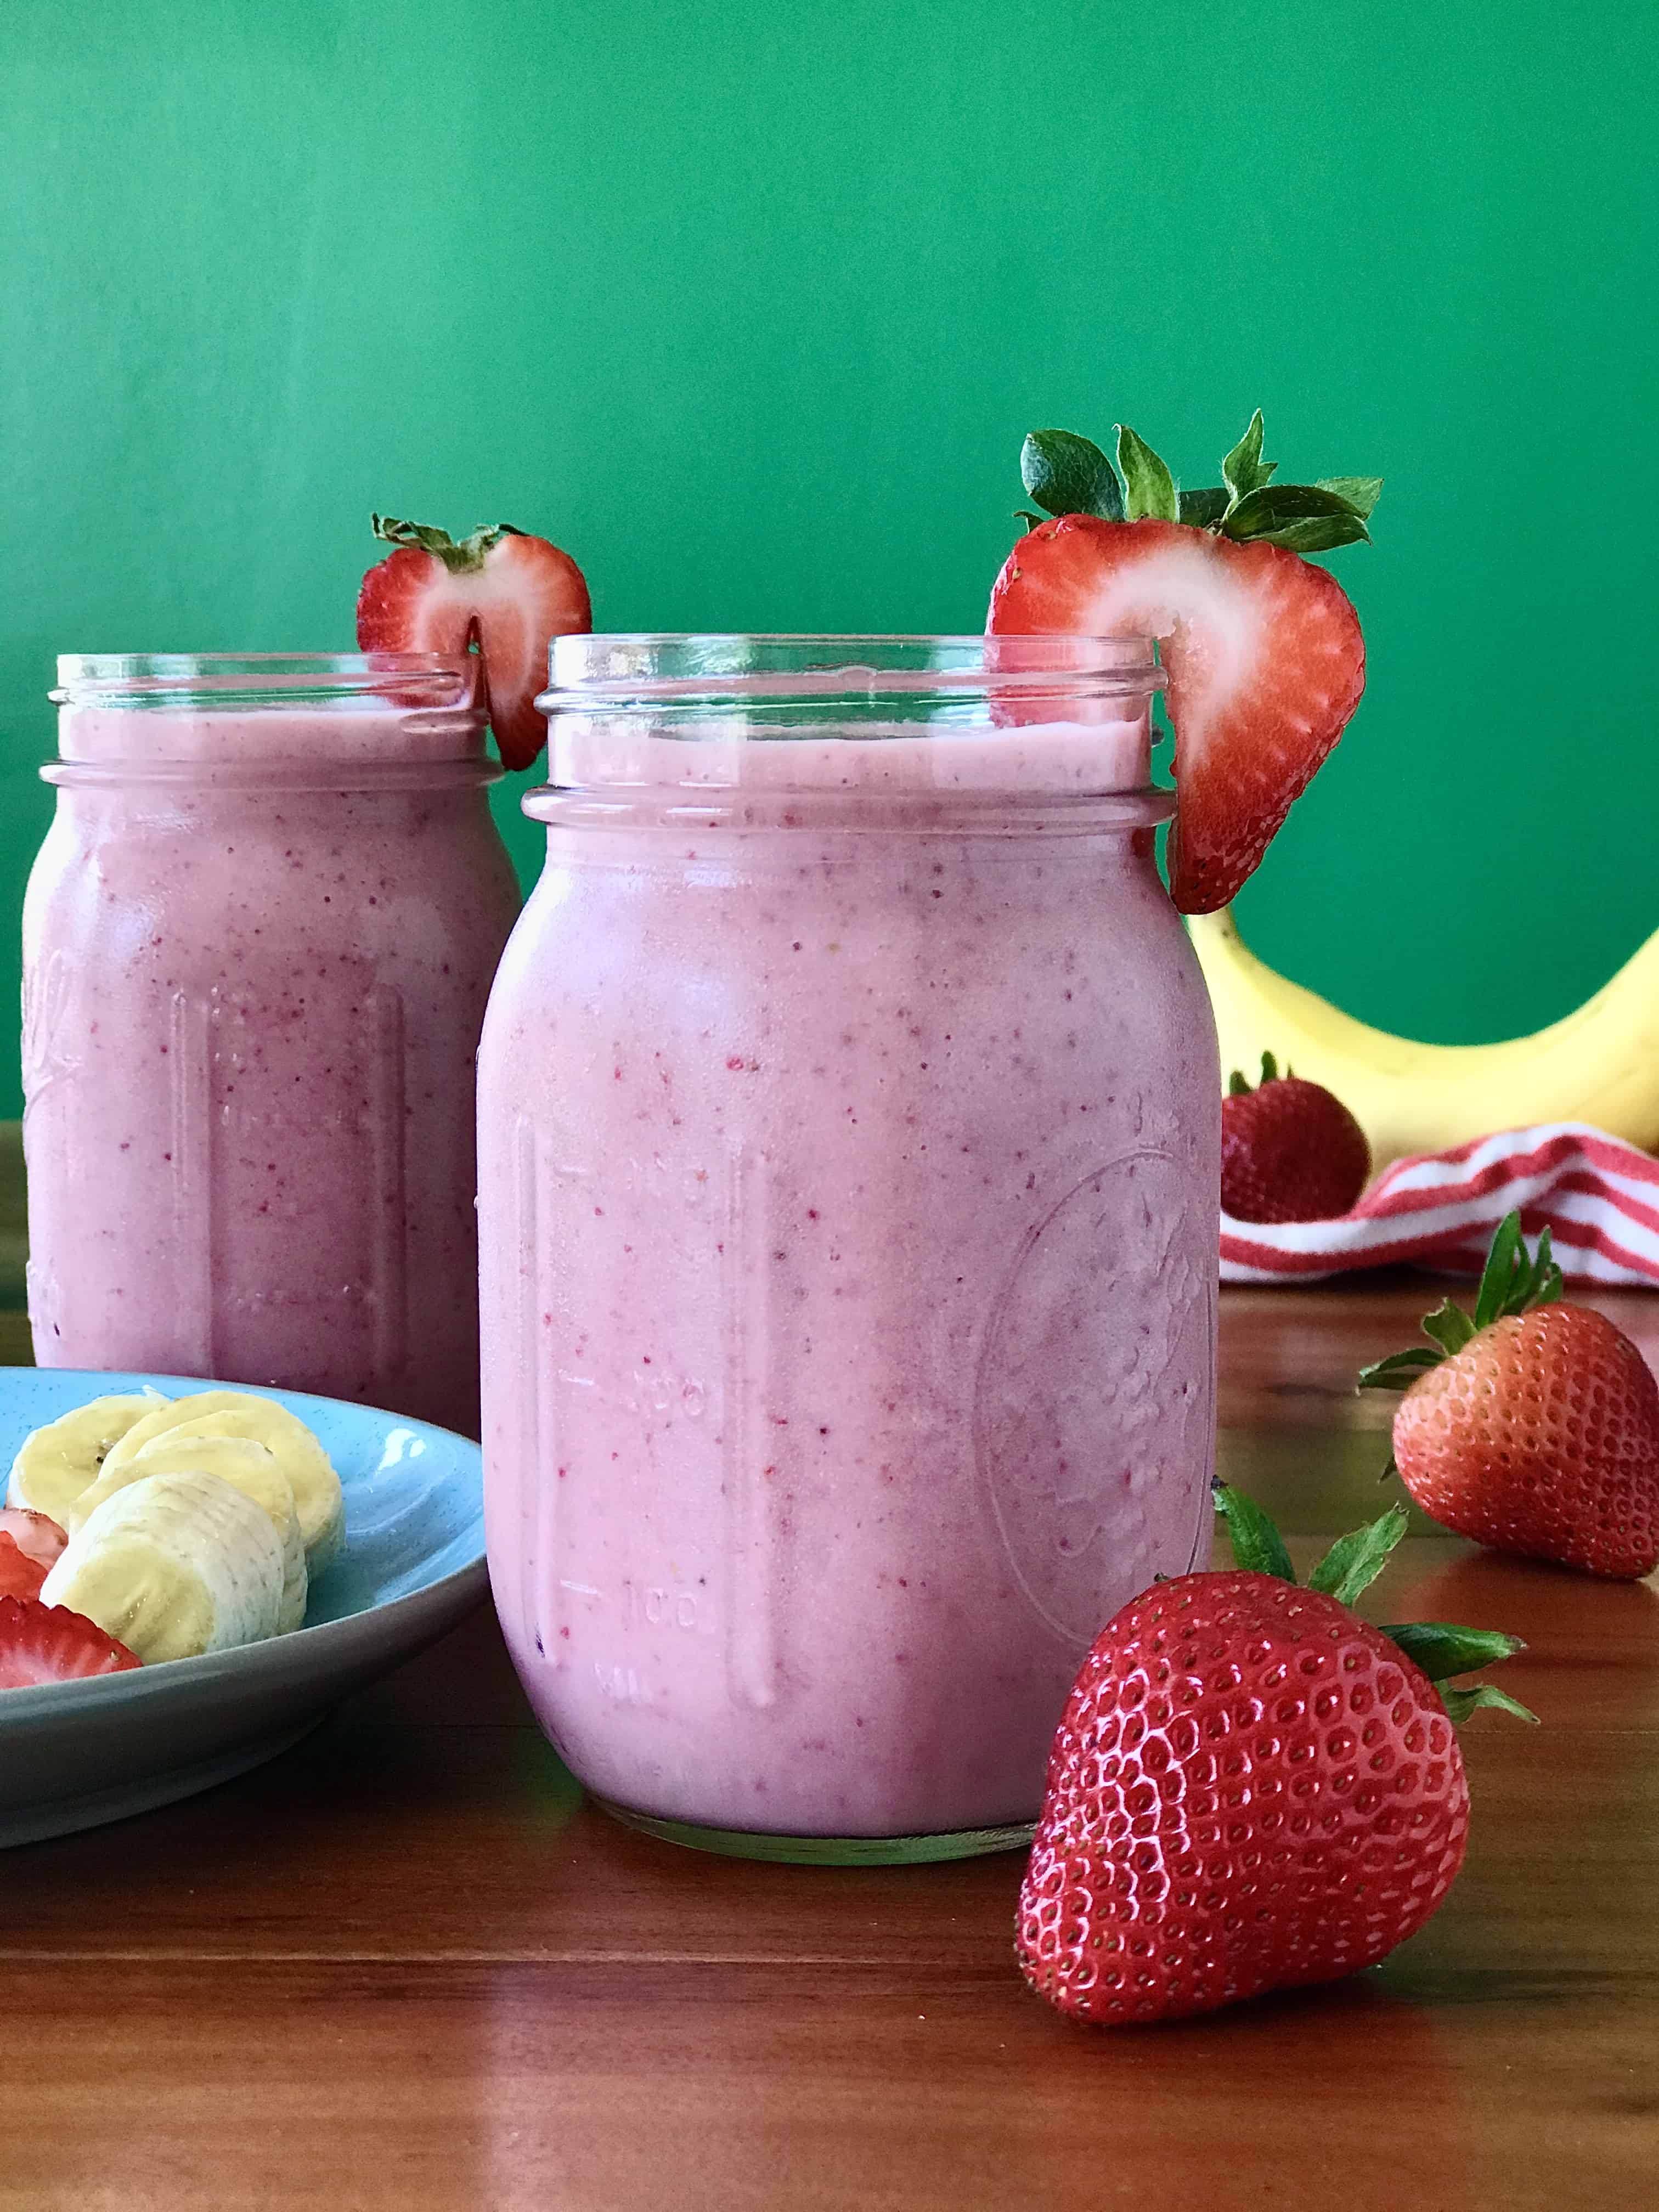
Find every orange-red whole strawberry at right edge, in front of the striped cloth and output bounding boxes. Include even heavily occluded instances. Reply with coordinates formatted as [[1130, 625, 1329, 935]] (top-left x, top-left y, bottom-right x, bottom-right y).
[[1361, 1215, 1659, 1582]]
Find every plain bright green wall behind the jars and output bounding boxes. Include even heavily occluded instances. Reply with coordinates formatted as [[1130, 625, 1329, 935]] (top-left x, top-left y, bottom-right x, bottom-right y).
[[0, 0, 1659, 1110]]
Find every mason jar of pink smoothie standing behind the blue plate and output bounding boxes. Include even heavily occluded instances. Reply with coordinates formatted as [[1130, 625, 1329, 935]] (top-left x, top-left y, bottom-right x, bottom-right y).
[[24, 652, 517, 1436]]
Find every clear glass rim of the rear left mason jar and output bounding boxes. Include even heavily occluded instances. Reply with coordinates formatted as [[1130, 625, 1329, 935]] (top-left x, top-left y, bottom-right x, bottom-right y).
[[49, 652, 482, 712]]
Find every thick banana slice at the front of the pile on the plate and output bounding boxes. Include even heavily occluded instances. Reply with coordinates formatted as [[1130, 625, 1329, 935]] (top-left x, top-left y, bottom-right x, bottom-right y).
[[40, 1475, 283, 1666]]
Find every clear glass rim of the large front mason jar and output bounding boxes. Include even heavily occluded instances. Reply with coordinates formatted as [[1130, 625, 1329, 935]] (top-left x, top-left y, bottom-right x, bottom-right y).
[[535, 630, 1164, 714]]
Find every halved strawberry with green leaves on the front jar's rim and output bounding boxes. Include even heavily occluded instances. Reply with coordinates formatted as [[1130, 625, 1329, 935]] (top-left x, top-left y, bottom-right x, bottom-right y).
[[986, 411, 1383, 913]]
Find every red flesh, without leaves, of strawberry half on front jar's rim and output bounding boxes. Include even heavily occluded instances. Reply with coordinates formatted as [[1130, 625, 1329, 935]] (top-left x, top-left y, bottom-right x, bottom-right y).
[[986, 515, 1365, 913]]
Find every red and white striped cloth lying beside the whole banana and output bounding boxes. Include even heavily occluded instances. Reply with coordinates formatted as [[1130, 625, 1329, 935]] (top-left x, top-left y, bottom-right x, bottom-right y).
[[1221, 1121, 1659, 1288]]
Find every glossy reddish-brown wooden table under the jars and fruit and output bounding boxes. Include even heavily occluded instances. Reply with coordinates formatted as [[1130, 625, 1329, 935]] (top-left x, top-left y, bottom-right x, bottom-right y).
[[0, 1278, 1659, 2212]]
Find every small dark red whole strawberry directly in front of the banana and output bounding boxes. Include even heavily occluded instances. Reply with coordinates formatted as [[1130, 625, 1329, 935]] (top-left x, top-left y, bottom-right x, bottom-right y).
[[1221, 1053, 1372, 1221]]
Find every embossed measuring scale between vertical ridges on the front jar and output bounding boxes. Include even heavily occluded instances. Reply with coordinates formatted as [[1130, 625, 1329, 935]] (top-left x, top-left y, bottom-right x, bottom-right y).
[[513, 1115, 781, 1706]]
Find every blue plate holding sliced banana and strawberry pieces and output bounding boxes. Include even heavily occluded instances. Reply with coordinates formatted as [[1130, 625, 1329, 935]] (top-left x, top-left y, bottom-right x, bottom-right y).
[[0, 1367, 489, 1845]]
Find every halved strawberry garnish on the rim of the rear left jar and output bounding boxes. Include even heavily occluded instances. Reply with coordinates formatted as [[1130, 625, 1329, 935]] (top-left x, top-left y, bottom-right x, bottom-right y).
[[356, 515, 593, 768]]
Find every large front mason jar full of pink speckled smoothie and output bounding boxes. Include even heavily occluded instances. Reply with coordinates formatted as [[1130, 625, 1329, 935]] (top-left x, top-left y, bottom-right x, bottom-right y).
[[480, 637, 1219, 1860]]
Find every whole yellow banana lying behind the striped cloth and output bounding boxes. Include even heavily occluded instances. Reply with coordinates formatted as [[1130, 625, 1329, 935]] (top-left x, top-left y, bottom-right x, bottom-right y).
[[1188, 911, 1659, 1168]]
